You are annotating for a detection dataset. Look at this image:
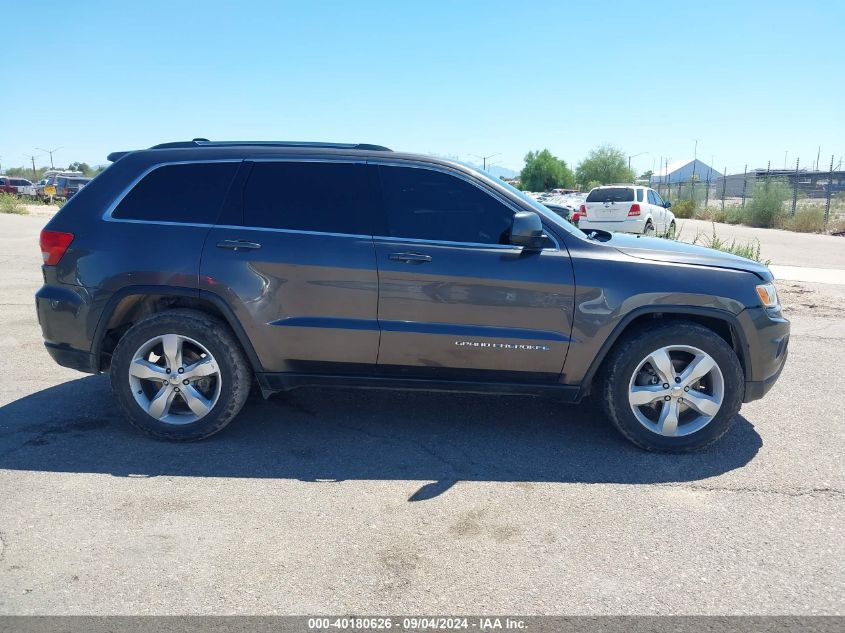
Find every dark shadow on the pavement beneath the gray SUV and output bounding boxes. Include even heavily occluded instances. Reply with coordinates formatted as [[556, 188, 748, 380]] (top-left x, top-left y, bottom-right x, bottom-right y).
[[0, 376, 762, 501]]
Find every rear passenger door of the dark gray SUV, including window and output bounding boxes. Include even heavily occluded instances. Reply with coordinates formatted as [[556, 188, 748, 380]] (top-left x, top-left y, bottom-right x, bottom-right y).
[[200, 159, 379, 374]]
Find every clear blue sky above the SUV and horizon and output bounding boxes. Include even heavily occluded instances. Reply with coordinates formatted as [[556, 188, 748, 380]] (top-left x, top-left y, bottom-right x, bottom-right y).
[[0, 0, 845, 171]]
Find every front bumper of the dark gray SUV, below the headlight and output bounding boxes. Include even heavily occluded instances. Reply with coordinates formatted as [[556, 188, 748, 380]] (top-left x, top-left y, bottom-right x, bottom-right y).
[[738, 308, 790, 402]]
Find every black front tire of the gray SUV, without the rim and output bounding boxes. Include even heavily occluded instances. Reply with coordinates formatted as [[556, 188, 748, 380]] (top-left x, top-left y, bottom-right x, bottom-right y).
[[598, 321, 745, 453]]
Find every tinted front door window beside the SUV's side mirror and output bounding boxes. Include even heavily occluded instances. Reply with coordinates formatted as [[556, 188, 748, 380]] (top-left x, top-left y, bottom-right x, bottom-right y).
[[379, 167, 513, 244]]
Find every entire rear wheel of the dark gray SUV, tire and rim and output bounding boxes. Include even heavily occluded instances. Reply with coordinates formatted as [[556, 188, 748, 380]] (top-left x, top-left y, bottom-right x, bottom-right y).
[[111, 310, 251, 441]]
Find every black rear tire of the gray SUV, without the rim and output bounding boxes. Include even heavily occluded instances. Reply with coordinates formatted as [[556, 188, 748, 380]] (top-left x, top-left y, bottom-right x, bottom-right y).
[[110, 309, 252, 442]]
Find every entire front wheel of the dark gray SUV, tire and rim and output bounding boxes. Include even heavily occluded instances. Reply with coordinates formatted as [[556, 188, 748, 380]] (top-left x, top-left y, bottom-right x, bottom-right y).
[[601, 322, 744, 452]]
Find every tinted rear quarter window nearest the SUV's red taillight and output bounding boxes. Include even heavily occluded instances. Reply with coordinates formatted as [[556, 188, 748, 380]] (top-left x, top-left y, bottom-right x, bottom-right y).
[[112, 163, 238, 224]]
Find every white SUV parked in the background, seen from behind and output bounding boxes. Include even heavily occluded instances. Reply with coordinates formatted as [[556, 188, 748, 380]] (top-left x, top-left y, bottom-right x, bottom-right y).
[[578, 185, 676, 235]]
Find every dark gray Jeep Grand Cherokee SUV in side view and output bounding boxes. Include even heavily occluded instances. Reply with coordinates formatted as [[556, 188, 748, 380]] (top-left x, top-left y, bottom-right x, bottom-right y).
[[36, 140, 789, 451]]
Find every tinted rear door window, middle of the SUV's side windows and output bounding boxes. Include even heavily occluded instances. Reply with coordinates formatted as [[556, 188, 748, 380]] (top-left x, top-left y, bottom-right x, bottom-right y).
[[244, 162, 373, 235]]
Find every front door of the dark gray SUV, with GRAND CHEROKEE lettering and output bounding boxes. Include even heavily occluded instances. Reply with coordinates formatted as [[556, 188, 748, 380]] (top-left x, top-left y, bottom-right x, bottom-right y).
[[376, 165, 574, 382]]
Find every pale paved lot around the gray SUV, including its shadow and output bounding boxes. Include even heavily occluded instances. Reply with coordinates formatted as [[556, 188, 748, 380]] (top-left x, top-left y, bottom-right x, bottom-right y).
[[0, 216, 845, 614]]
